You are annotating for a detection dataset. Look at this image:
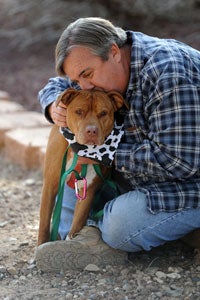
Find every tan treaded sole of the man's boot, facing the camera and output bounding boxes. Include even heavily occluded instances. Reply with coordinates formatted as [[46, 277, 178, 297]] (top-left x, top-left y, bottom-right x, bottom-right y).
[[35, 241, 128, 272]]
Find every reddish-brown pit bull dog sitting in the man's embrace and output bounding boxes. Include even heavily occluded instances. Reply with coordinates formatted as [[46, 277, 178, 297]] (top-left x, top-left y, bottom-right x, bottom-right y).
[[38, 88, 124, 245]]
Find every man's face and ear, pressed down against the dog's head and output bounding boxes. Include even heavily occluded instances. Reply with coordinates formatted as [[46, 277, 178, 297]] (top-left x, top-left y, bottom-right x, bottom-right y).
[[63, 45, 127, 93]]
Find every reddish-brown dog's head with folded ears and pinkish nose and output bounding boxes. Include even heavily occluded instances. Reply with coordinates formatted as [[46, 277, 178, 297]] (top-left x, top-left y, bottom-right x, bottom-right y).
[[56, 88, 124, 145]]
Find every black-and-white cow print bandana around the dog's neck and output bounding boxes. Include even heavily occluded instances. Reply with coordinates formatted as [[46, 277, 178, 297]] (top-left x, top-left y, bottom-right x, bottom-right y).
[[60, 122, 124, 166]]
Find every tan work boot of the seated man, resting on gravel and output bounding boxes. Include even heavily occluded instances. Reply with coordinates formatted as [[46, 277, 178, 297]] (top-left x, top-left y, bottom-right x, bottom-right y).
[[35, 226, 128, 272]]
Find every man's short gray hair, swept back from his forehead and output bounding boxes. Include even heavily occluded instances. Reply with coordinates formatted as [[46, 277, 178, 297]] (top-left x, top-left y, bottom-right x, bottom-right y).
[[55, 17, 127, 76]]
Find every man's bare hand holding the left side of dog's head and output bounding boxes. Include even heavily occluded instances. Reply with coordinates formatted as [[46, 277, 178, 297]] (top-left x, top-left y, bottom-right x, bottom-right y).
[[49, 102, 67, 127]]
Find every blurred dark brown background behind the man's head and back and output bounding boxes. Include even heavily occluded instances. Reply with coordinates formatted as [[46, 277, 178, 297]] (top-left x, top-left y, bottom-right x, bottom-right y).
[[0, 0, 200, 111]]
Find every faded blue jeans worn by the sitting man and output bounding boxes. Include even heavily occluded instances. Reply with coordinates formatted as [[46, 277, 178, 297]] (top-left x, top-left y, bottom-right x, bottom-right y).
[[59, 185, 200, 252]]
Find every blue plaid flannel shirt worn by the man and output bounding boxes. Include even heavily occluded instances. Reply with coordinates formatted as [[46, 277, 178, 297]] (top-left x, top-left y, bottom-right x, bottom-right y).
[[39, 31, 200, 213]]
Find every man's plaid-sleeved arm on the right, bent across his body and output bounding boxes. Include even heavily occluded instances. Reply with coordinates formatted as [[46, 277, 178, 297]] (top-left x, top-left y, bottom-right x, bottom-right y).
[[115, 75, 200, 179]]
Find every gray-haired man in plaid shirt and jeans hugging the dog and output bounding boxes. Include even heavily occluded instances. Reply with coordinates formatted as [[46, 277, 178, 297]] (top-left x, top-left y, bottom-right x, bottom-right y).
[[36, 18, 200, 270]]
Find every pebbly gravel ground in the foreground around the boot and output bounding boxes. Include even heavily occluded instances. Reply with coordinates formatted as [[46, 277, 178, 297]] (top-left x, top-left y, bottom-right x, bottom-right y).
[[0, 152, 200, 300]]
